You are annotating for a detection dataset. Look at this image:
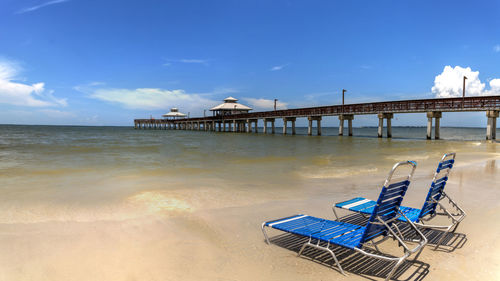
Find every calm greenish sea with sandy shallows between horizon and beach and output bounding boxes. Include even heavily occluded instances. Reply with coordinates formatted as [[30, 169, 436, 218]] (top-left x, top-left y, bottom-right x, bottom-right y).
[[0, 125, 500, 223]]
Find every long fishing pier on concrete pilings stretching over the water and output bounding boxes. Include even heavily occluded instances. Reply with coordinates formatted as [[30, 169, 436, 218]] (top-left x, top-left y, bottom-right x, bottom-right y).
[[134, 96, 500, 140]]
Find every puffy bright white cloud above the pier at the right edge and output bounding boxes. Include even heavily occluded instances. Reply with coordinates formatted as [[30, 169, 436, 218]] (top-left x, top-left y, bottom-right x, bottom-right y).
[[432, 65, 500, 98]]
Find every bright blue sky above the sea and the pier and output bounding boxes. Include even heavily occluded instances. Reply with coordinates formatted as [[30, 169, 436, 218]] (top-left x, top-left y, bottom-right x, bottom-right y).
[[0, 0, 500, 126]]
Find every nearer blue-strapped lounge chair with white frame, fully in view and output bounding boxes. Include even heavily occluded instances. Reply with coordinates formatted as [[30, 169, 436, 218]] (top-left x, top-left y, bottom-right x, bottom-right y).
[[262, 161, 427, 280]]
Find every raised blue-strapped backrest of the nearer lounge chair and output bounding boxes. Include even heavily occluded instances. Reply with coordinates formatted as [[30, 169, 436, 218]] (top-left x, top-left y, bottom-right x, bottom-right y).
[[360, 161, 417, 243]]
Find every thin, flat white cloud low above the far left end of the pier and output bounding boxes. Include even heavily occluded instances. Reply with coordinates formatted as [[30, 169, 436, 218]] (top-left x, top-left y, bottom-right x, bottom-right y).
[[90, 88, 220, 112]]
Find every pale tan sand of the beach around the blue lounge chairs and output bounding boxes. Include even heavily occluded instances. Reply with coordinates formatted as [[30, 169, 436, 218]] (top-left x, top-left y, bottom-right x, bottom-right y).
[[0, 153, 500, 281]]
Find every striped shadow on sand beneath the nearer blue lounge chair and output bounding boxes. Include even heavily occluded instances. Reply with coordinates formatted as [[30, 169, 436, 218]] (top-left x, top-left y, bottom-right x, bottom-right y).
[[269, 233, 430, 281]]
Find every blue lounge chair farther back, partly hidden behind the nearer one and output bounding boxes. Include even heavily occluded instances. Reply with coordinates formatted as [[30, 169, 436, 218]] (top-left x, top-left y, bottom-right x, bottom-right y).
[[332, 153, 466, 249]]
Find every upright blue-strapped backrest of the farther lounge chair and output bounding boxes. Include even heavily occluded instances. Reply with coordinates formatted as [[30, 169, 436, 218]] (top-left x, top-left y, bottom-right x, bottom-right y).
[[418, 152, 455, 218]]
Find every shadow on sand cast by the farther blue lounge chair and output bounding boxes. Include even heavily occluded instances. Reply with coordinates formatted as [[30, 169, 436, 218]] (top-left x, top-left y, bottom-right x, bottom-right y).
[[338, 213, 467, 253]]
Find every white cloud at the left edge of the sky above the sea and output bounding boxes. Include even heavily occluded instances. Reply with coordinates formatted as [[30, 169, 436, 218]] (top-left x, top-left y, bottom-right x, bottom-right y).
[[0, 60, 67, 107]]
